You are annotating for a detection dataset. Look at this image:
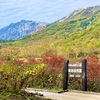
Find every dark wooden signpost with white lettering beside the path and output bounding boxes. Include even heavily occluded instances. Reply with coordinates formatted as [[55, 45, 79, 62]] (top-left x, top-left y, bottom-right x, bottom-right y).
[[63, 59, 87, 91]]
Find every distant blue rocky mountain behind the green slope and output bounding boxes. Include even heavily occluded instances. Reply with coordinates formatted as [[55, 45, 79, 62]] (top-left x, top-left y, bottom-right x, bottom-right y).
[[0, 20, 46, 40]]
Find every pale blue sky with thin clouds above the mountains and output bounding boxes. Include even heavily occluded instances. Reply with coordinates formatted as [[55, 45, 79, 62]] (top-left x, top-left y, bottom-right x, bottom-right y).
[[0, 0, 100, 28]]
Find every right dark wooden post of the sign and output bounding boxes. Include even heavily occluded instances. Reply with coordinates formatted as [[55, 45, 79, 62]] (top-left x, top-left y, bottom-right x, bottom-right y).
[[82, 59, 87, 91]]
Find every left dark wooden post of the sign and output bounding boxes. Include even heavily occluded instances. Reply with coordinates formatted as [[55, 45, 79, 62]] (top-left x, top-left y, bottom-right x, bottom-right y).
[[63, 60, 69, 90]]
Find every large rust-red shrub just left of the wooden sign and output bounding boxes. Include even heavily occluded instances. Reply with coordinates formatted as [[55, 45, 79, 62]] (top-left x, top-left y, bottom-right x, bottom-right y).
[[41, 51, 64, 73]]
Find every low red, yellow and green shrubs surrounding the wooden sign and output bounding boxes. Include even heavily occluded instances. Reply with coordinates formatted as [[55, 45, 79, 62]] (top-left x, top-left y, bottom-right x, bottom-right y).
[[0, 51, 100, 100]]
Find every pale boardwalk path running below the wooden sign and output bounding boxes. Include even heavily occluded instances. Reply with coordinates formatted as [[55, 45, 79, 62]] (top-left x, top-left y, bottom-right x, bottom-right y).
[[25, 88, 100, 100]]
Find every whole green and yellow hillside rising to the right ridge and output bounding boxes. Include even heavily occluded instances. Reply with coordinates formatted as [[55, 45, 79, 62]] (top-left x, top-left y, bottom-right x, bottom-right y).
[[0, 6, 100, 58]]
